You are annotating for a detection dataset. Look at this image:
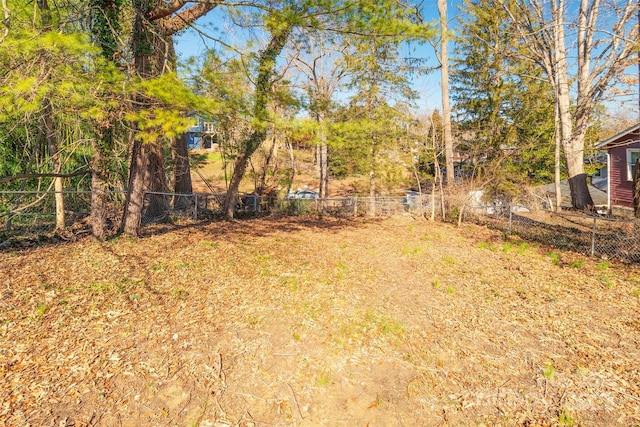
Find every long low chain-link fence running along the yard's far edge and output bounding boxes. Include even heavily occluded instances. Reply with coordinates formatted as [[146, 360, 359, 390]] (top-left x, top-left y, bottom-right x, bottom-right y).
[[0, 191, 640, 263]]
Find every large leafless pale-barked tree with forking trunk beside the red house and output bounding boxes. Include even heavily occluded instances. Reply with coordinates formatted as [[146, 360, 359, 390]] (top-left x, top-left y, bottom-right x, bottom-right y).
[[502, 0, 640, 210]]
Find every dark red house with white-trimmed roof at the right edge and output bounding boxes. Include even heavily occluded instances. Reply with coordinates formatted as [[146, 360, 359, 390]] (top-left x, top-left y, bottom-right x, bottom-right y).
[[596, 123, 640, 215]]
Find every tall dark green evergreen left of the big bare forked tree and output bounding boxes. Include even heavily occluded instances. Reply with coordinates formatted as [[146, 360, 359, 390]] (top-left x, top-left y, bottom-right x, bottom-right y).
[[452, 0, 554, 196]]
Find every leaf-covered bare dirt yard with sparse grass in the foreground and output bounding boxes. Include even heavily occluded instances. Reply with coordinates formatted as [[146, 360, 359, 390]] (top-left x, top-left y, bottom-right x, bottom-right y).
[[0, 217, 640, 427]]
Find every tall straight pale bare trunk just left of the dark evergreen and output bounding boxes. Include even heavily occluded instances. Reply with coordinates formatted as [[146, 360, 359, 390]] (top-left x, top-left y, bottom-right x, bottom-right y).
[[438, 0, 455, 187]]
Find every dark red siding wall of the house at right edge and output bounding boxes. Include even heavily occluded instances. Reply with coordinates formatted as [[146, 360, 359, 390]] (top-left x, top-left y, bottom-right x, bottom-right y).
[[609, 135, 640, 207]]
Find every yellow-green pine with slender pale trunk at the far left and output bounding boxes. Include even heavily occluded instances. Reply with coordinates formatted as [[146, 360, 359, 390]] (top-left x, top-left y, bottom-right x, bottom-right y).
[[0, 0, 115, 234]]
